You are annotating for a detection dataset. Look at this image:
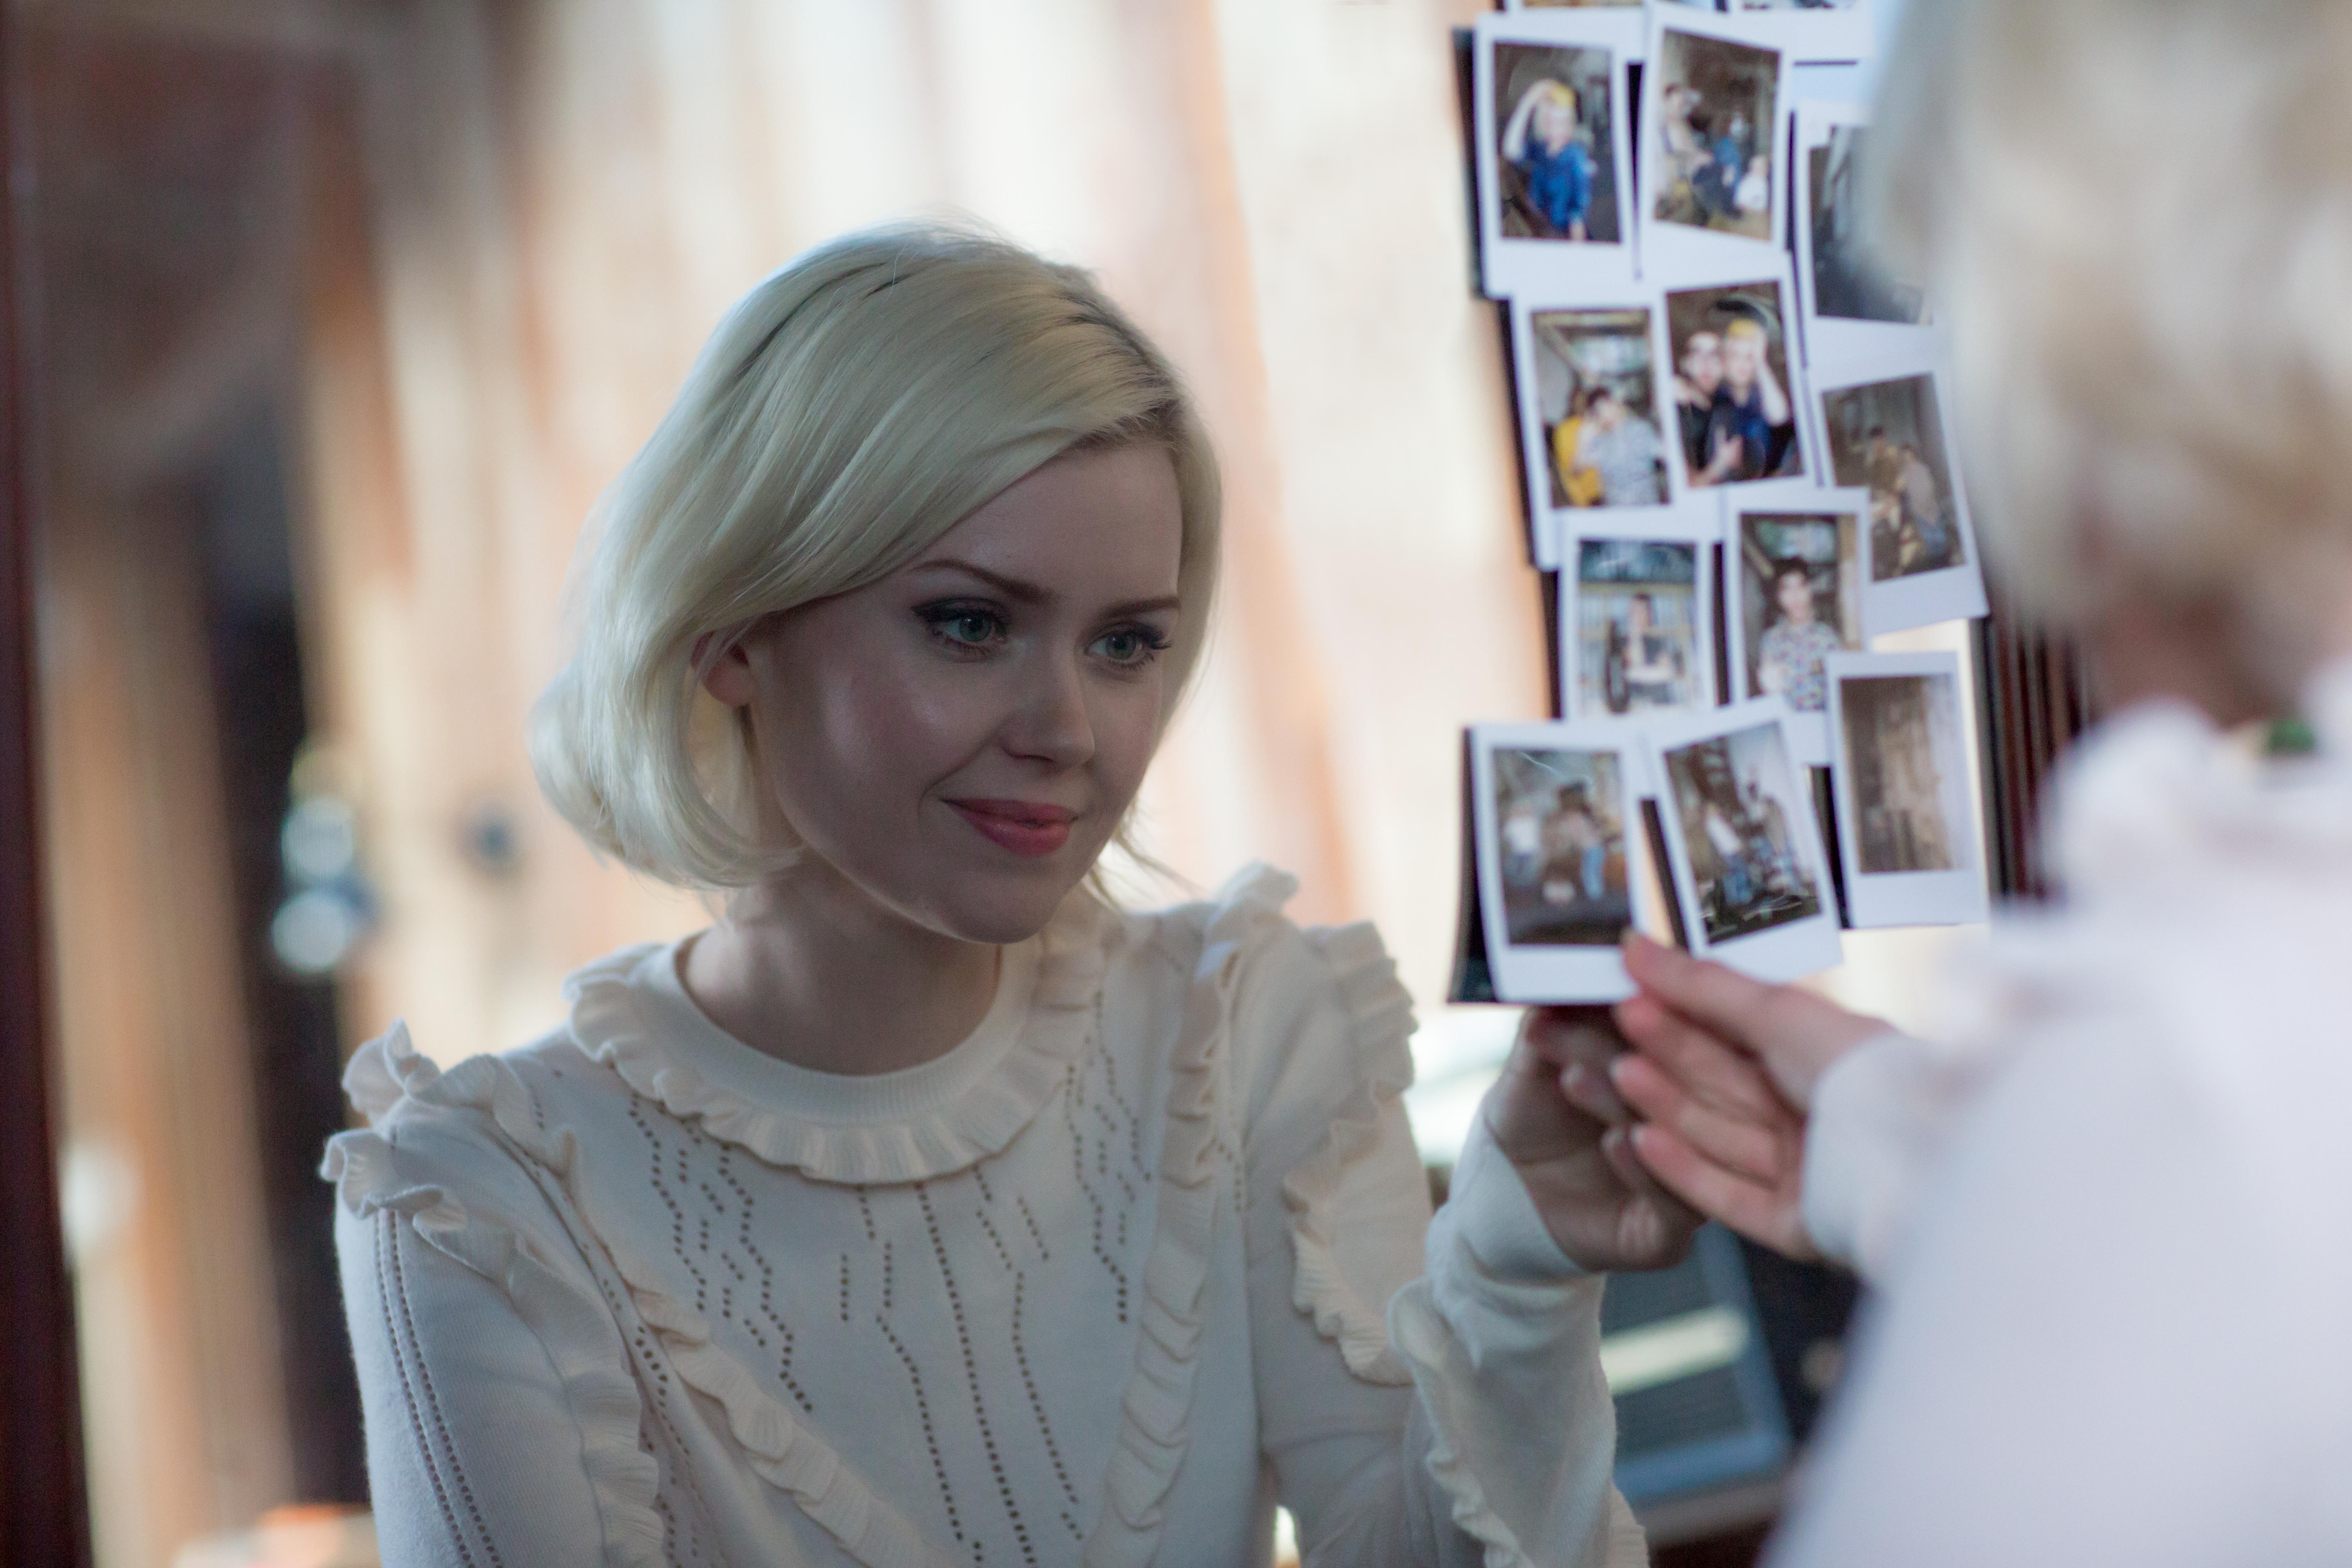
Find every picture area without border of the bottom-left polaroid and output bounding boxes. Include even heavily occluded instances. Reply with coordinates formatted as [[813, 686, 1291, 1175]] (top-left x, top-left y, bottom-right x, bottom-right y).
[[1494, 748, 1632, 947]]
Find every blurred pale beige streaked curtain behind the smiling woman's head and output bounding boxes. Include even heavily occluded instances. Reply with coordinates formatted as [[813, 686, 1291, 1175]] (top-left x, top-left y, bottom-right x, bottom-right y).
[[313, 0, 1543, 1060]]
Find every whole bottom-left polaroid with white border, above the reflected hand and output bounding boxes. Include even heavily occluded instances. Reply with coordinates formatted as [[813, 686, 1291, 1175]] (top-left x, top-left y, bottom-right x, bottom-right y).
[[1470, 724, 1656, 1002]]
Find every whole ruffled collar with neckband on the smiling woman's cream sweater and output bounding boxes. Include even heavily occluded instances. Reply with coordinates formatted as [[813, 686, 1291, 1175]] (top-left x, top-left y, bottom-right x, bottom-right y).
[[564, 891, 1122, 1183]]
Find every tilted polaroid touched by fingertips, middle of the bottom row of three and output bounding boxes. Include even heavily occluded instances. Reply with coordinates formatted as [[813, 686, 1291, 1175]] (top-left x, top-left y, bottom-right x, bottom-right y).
[[1646, 698, 1844, 980]]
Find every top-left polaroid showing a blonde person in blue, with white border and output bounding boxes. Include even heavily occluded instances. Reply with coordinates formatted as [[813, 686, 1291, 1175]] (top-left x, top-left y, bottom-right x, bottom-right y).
[[1472, 12, 1635, 298]]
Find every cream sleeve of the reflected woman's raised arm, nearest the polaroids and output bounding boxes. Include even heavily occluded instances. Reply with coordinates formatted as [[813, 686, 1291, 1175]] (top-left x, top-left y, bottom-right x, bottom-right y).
[[1235, 884, 1644, 1568]]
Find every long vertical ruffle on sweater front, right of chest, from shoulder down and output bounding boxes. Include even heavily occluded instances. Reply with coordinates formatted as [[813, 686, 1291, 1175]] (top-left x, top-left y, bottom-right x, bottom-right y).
[[1084, 865, 1298, 1568]]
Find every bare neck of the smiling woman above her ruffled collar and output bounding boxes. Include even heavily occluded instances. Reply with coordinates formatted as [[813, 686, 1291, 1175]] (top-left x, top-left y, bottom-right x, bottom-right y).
[[680, 858, 1000, 1074]]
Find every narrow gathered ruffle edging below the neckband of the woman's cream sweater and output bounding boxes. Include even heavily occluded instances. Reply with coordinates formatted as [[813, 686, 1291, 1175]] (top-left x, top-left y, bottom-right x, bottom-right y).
[[564, 893, 1122, 1185]]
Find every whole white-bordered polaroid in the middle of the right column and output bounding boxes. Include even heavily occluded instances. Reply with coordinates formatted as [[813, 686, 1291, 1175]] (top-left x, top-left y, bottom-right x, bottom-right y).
[[1813, 355, 1985, 635]]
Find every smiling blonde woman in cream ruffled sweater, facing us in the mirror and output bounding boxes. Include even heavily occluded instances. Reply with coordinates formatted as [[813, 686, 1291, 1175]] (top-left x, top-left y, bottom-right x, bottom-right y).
[[327, 230, 1696, 1568]]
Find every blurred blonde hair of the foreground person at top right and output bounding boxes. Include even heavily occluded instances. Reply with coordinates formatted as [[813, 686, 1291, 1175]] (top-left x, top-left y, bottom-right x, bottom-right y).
[[1865, 0, 2352, 675]]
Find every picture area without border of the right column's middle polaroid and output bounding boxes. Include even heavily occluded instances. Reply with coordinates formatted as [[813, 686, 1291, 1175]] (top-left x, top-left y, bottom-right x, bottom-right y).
[[1820, 376, 1966, 583]]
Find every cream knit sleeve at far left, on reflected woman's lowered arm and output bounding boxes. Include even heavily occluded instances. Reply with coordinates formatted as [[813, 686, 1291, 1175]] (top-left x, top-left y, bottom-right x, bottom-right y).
[[325, 1027, 663, 1568]]
